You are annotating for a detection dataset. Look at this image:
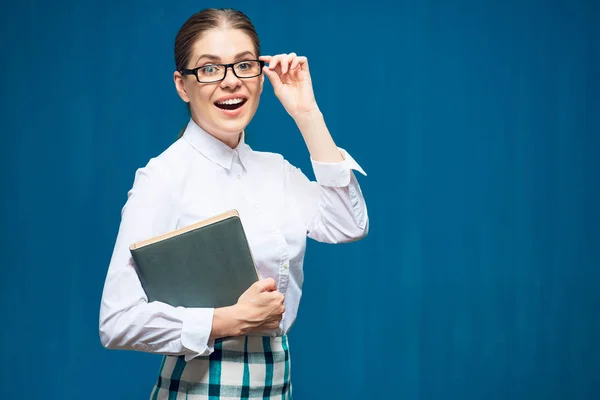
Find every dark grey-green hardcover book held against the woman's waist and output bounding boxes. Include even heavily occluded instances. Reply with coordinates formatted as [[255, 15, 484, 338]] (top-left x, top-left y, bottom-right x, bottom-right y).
[[129, 210, 259, 308]]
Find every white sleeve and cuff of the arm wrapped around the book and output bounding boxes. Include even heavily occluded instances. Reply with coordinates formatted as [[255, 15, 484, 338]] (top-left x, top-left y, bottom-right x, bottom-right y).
[[100, 160, 214, 360]]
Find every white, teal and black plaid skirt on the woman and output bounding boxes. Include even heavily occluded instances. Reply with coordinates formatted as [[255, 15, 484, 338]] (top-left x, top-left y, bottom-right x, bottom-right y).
[[150, 335, 292, 400]]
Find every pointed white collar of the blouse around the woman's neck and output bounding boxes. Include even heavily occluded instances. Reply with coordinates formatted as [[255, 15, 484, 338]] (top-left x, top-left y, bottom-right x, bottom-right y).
[[183, 118, 248, 170]]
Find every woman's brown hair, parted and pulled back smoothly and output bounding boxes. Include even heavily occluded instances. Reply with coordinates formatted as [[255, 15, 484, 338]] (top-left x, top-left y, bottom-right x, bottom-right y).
[[175, 8, 260, 138]]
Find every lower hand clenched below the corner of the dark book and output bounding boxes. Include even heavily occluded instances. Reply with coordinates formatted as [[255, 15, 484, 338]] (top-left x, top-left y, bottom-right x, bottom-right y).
[[233, 278, 285, 335]]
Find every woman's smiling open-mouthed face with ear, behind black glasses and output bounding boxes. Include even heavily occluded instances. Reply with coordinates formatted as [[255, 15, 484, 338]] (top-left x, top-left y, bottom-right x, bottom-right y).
[[174, 29, 264, 147]]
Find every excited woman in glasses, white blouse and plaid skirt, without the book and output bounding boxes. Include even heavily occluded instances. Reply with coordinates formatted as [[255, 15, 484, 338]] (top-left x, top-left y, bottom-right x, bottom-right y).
[[100, 9, 368, 399]]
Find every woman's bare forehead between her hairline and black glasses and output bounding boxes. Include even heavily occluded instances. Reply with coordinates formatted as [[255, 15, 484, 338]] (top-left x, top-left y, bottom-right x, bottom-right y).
[[192, 29, 257, 62]]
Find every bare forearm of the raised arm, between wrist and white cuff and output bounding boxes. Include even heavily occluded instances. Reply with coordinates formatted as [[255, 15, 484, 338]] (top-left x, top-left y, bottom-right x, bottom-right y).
[[294, 109, 344, 163]]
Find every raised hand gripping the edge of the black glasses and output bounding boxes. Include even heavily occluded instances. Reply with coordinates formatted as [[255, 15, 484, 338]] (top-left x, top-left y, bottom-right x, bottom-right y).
[[260, 53, 319, 119]]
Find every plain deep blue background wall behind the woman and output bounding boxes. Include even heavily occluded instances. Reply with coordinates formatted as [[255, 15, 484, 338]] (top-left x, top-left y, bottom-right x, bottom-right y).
[[0, 0, 600, 400]]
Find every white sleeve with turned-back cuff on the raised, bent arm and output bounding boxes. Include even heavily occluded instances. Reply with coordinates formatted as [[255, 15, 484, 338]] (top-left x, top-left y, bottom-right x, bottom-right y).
[[286, 149, 369, 243]]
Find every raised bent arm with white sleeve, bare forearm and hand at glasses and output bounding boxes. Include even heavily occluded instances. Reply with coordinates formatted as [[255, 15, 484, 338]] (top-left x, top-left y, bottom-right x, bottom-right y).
[[261, 53, 368, 243]]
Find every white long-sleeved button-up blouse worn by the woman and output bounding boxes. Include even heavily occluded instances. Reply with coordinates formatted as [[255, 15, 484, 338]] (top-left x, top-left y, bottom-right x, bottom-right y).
[[100, 120, 368, 361]]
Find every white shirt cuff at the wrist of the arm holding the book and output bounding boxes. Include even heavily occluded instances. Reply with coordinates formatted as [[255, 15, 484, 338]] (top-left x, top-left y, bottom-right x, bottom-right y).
[[181, 308, 215, 362]]
